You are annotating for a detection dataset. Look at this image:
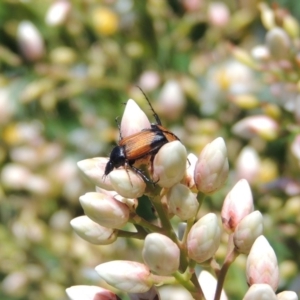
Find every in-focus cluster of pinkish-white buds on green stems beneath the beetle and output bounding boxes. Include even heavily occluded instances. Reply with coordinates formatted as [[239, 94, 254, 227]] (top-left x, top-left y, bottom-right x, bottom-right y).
[[67, 100, 297, 300]]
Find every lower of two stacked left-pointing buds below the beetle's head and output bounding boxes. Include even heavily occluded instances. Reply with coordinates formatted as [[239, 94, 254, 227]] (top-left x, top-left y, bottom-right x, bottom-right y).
[[70, 216, 118, 245]]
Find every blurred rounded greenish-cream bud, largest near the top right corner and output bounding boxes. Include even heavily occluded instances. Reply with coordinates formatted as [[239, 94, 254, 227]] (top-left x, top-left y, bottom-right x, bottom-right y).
[[266, 27, 291, 59]]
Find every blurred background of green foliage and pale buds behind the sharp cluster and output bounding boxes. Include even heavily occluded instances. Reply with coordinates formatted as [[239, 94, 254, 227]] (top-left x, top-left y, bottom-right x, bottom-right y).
[[0, 0, 300, 300]]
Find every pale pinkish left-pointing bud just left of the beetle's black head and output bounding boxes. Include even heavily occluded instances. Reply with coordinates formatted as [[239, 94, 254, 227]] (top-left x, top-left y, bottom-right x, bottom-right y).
[[77, 157, 114, 191]]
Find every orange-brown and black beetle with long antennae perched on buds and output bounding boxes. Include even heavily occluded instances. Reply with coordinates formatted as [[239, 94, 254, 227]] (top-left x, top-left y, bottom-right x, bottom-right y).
[[104, 88, 179, 183]]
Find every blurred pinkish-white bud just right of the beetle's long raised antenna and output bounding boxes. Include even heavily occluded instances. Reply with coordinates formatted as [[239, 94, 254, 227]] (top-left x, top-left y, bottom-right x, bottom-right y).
[[158, 80, 186, 120]]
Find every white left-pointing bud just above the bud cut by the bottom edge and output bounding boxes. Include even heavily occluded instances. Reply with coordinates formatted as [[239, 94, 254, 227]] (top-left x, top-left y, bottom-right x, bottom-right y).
[[95, 260, 153, 293]]
